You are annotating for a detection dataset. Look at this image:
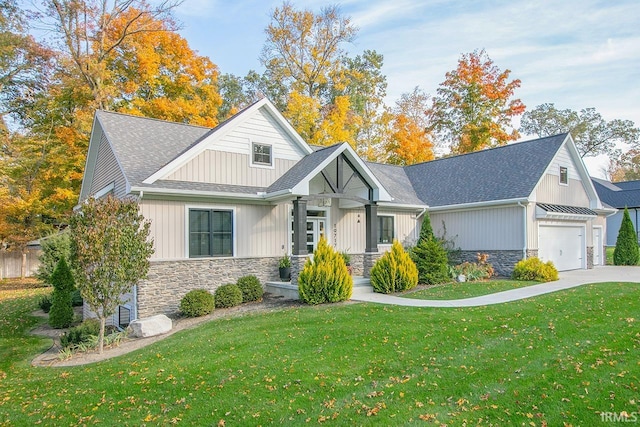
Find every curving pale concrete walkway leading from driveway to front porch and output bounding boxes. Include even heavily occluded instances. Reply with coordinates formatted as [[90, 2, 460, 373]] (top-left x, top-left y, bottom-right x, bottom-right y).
[[351, 266, 640, 307]]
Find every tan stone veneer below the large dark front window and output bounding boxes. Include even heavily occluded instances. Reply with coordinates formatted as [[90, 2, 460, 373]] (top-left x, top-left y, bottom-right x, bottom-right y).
[[138, 257, 280, 318]]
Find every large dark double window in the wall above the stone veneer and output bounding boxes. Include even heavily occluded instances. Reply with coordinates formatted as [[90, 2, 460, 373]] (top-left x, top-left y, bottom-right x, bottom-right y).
[[189, 209, 233, 258]]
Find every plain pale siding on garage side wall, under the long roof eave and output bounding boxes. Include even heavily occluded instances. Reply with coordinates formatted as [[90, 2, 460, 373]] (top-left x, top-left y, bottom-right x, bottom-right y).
[[431, 206, 524, 251]]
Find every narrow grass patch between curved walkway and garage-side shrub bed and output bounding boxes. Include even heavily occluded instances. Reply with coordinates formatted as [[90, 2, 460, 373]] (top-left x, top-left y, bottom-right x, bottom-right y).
[[401, 280, 539, 300]]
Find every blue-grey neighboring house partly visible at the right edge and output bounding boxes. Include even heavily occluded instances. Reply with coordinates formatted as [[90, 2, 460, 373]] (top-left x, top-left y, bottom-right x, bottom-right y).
[[591, 178, 640, 246]]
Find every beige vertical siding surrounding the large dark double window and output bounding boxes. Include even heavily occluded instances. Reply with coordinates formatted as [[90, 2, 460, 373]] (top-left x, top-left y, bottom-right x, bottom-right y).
[[140, 198, 290, 260]]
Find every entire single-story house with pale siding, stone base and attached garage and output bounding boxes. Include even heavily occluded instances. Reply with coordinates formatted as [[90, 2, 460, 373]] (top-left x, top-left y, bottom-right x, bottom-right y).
[[80, 99, 609, 324]]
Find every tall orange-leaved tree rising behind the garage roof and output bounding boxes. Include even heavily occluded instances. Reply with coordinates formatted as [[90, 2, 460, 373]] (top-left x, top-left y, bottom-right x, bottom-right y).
[[429, 49, 525, 154]]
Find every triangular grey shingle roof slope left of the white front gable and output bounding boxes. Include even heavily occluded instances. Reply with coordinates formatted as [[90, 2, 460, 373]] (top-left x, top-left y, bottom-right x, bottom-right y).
[[96, 111, 211, 185]]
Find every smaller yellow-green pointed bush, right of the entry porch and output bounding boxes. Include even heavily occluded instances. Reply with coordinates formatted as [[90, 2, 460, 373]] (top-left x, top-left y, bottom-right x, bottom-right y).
[[371, 240, 418, 294]]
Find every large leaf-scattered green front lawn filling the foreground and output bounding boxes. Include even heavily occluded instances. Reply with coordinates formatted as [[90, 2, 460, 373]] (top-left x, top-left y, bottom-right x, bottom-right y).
[[0, 283, 640, 426]]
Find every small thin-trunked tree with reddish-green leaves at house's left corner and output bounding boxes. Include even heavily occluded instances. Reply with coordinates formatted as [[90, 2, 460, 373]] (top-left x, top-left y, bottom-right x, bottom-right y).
[[70, 196, 153, 353]]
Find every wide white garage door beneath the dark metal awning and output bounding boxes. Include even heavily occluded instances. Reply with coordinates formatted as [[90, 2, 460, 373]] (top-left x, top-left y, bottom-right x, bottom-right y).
[[538, 225, 585, 271]]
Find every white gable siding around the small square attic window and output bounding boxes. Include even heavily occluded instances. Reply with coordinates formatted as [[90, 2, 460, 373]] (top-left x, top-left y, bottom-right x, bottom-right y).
[[165, 109, 305, 187]]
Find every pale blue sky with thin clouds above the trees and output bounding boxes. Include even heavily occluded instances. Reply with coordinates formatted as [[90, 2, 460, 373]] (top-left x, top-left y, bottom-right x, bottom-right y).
[[171, 0, 640, 175]]
